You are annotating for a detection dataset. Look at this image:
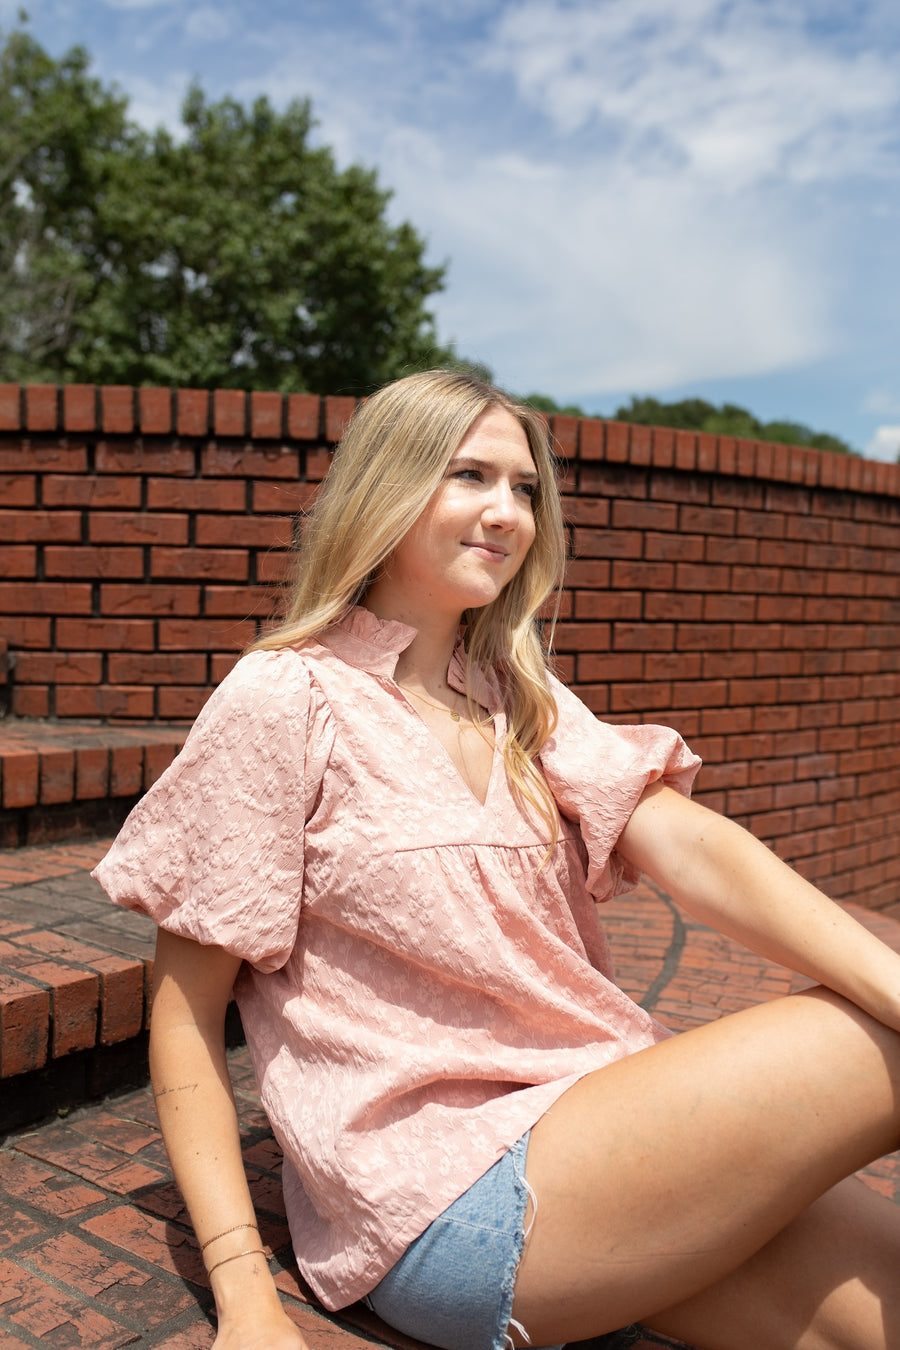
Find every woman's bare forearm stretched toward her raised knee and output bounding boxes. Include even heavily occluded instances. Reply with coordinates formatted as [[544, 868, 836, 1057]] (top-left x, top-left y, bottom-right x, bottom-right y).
[[618, 783, 900, 1030]]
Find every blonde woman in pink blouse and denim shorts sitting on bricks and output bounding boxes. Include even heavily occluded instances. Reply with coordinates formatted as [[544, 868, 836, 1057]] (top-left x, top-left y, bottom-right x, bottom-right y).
[[97, 371, 900, 1350]]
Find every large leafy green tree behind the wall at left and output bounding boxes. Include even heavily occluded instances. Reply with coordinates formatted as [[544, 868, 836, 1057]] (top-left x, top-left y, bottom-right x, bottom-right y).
[[0, 30, 453, 393]]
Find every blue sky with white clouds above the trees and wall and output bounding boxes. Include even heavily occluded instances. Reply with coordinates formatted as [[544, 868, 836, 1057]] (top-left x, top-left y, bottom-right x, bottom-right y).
[[0, 0, 900, 460]]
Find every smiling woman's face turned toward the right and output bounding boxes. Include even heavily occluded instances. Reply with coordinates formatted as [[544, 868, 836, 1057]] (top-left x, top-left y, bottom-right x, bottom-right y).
[[367, 408, 538, 621]]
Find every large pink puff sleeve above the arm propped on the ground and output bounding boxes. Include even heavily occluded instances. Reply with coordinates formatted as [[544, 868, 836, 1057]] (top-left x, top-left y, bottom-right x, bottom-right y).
[[93, 649, 317, 971]]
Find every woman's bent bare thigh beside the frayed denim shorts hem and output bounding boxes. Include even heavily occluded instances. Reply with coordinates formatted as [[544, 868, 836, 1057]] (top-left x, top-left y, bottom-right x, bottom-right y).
[[514, 990, 900, 1350]]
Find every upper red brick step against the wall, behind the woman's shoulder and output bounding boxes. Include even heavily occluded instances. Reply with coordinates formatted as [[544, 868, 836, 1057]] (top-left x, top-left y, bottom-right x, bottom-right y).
[[0, 718, 188, 848]]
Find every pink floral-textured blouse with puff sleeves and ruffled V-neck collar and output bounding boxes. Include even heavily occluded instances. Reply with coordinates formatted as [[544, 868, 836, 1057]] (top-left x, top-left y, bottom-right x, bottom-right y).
[[94, 609, 699, 1308]]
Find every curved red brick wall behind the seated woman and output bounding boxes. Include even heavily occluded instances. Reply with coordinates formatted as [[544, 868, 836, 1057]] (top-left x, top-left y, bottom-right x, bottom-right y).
[[0, 385, 900, 906]]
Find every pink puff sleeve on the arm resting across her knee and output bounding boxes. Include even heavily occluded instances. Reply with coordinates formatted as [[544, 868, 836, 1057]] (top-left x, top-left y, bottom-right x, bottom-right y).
[[540, 679, 700, 900]]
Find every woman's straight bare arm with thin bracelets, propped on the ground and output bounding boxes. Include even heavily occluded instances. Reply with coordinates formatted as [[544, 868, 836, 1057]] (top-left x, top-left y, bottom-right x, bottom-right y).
[[150, 929, 308, 1350]]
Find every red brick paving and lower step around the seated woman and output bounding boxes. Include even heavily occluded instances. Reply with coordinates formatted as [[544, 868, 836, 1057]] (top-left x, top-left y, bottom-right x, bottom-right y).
[[0, 840, 900, 1350]]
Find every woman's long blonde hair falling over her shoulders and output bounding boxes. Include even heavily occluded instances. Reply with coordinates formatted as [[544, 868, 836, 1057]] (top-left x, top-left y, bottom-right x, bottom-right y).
[[254, 370, 565, 840]]
